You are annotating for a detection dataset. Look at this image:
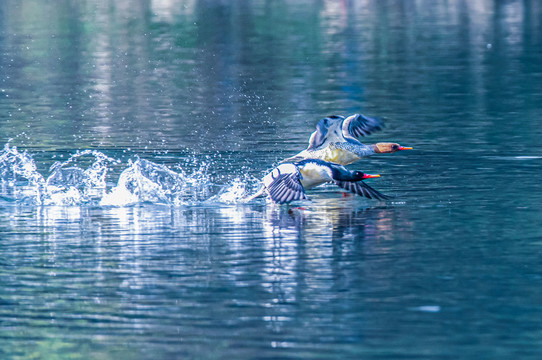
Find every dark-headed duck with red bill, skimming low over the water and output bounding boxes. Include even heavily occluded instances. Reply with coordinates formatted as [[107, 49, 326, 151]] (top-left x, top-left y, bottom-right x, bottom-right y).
[[248, 159, 390, 204]]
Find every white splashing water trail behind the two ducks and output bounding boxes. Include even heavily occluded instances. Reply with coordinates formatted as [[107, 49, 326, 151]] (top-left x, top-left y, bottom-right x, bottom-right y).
[[0, 143, 258, 206]]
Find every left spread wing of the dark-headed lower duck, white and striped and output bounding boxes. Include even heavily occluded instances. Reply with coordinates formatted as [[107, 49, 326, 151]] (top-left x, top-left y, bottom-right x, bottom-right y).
[[263, 164, 307, 204]]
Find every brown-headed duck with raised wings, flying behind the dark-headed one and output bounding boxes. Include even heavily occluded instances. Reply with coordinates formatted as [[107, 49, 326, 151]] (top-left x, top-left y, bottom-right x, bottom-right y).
[[281, 114, 413, 165]]
